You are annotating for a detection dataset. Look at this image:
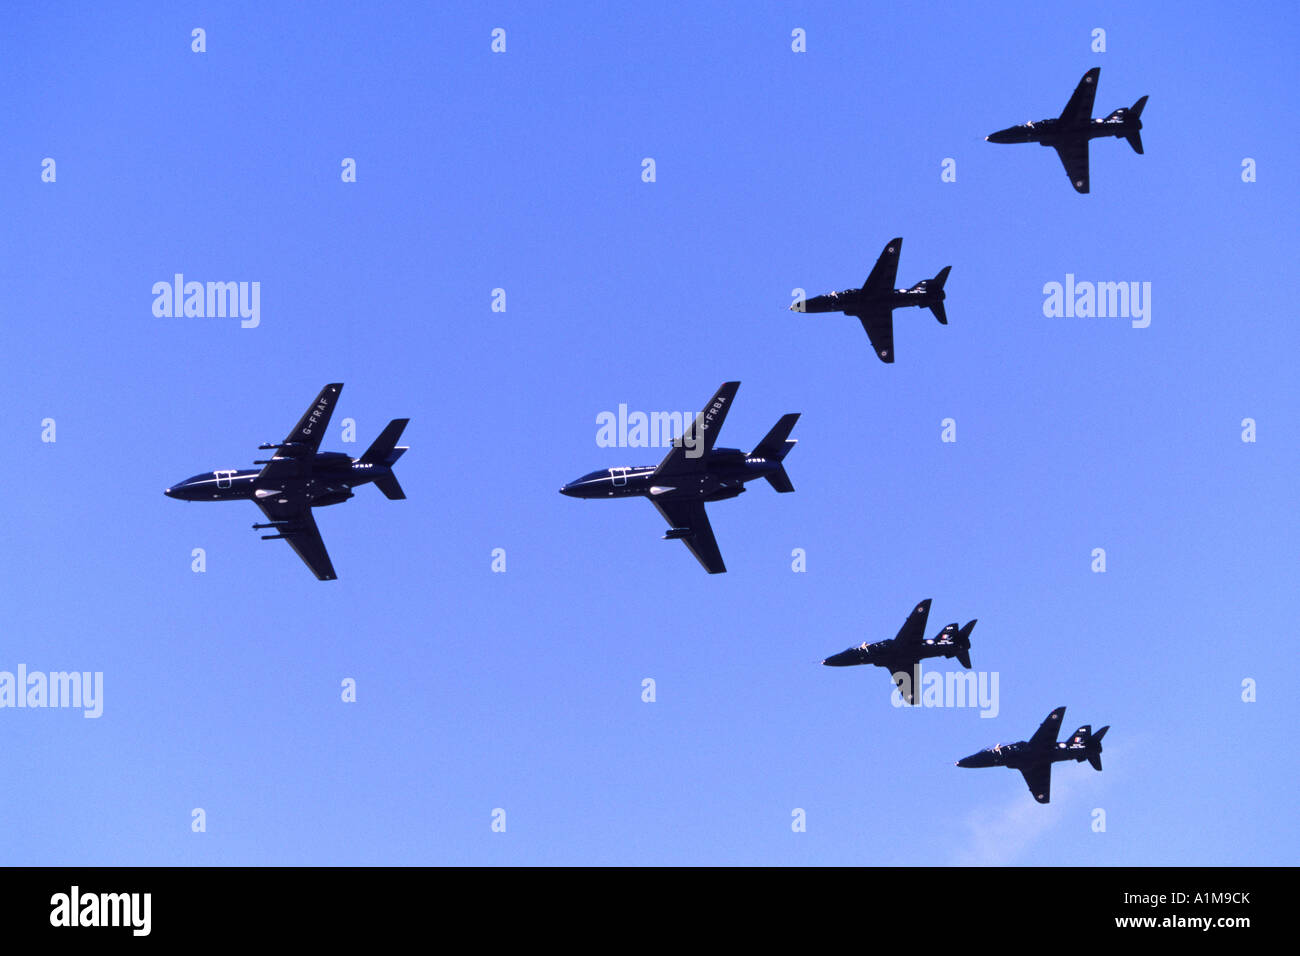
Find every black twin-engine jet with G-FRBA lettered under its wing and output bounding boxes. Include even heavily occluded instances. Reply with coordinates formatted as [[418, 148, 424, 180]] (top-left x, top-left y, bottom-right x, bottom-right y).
[[560, 381, 800, 575]]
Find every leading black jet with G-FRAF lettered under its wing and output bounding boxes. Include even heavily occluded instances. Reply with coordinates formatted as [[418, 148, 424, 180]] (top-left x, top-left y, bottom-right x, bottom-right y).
[[163, 382, 410, 581]]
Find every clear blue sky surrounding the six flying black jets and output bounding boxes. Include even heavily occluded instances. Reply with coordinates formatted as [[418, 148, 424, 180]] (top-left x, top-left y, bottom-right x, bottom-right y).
[[0, 3, 1300, 865]]
